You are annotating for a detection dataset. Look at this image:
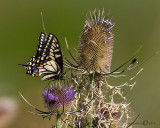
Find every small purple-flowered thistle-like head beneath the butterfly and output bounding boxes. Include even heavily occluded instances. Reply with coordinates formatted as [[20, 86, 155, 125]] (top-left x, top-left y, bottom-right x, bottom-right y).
[[42, 86, 75, 111]]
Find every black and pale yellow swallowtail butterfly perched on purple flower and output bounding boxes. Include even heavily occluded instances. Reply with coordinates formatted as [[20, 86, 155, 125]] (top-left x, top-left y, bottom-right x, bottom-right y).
[[22, 33, 65, 80]]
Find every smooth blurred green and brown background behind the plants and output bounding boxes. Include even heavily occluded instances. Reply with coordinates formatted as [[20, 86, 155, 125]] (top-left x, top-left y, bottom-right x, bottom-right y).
[[0, 0, 160, 128]]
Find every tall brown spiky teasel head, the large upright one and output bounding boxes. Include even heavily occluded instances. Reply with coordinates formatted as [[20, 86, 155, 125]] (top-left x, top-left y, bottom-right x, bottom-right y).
[[79, 10, 114, 74]]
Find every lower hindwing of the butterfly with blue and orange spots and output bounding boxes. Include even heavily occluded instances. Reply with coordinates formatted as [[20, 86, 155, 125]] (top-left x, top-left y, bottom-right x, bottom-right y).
[[25, 56, 61, 80]]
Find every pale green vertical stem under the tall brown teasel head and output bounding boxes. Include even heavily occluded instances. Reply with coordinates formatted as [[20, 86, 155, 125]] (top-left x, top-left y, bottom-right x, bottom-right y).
[[86, 74, 95, 128]]
